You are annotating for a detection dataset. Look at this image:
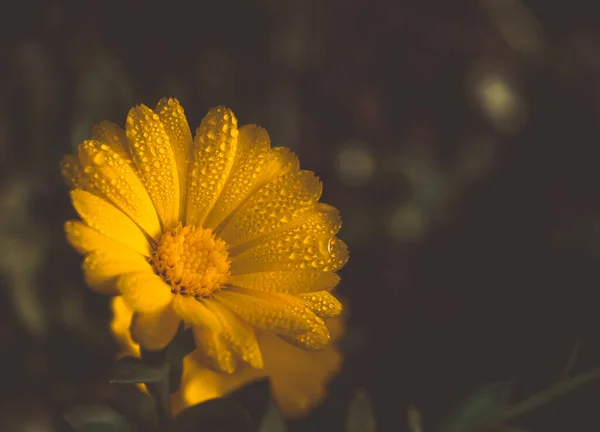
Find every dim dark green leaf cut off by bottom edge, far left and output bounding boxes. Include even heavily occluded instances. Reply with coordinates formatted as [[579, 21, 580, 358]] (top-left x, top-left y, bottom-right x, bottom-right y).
[[64, 405, 134, 432]]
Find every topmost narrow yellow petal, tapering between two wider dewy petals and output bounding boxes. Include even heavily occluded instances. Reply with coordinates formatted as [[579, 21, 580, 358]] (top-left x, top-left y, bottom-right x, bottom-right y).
[[154, 98, 192, 221]]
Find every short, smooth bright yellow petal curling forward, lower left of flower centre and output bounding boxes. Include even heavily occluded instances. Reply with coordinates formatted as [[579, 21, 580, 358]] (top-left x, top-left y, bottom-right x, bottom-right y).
[[117, 272, 173, 312]]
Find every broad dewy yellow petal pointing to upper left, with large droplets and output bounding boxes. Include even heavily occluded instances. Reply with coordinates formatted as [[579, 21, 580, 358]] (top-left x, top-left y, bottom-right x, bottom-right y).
[[79, 141, 161, 240]]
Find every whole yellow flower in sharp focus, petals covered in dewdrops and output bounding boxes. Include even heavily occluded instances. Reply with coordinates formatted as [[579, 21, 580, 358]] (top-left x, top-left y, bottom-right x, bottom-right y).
[[61, 99, 348, 373]]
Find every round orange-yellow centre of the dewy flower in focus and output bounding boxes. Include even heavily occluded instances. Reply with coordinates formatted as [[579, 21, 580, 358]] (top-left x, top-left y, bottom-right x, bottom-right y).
[[151, 224, 231, 297]]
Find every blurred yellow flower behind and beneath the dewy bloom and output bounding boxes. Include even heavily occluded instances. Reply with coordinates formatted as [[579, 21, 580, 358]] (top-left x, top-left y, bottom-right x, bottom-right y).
[[111, 297, 343, 417]]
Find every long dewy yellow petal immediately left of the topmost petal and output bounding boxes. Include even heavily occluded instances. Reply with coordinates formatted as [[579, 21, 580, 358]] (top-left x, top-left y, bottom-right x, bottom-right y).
[[126, 105, 179, 229]]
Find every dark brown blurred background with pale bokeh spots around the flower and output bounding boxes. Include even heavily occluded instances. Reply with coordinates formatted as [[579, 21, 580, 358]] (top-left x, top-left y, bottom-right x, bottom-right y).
[[0, 0, 600, 432]]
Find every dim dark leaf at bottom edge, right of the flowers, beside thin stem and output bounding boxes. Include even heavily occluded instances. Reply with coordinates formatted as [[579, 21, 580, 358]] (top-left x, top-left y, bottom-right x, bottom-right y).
[[440, 383, 511, 432]]
